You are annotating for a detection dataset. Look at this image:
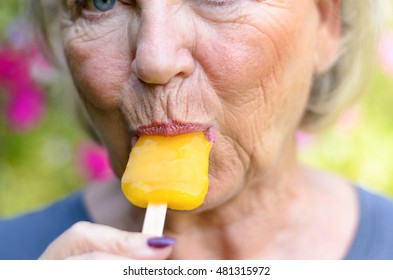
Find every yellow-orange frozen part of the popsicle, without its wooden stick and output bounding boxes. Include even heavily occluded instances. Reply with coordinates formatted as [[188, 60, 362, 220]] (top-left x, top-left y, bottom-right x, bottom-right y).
[[122, 132, 212, 210]]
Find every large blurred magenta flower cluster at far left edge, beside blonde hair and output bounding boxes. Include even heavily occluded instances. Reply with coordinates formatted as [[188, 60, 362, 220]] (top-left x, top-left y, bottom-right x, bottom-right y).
[[0, 19, 54, 132]]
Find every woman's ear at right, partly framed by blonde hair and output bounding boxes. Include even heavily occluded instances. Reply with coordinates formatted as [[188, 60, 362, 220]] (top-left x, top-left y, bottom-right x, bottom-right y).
[[314, 0, 341, 74]]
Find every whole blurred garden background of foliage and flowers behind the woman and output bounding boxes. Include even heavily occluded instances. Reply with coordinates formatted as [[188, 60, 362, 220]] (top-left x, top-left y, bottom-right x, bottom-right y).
[[0, 1, 393, 217]]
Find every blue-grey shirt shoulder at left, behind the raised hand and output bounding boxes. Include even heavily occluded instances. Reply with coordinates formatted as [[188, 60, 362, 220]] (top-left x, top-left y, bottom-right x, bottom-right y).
[[0, 193, 90, 259]]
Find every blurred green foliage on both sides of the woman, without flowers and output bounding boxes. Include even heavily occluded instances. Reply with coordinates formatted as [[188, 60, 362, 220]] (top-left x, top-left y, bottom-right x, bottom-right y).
[[0, 1, 393, 216]]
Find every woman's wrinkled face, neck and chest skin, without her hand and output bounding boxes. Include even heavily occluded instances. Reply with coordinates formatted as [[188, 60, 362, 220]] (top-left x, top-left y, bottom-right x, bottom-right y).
[[43, 0, 355, 258]]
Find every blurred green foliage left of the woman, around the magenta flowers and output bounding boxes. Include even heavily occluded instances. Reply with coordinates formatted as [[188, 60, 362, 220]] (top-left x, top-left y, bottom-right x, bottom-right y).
[[0, 0, 86, 216]]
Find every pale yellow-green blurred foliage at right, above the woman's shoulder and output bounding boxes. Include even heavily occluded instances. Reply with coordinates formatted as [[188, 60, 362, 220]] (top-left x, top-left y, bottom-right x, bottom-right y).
[[300, 69, 393, 195]]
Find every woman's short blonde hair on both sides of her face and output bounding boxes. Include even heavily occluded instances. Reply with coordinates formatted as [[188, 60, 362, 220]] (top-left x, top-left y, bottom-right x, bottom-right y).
[[30, 0, 391, 130]]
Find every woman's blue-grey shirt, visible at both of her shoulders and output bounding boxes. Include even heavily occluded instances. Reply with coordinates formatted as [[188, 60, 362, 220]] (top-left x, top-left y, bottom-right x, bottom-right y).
[[0, 188, 393, 260]]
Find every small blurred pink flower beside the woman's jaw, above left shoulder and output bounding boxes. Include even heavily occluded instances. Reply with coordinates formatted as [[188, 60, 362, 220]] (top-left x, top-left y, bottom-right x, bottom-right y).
[[76, 142, 114, 181]]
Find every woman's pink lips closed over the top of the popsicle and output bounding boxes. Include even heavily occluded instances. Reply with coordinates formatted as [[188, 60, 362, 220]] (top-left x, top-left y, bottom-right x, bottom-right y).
[[136, 121, 216, 143]]
